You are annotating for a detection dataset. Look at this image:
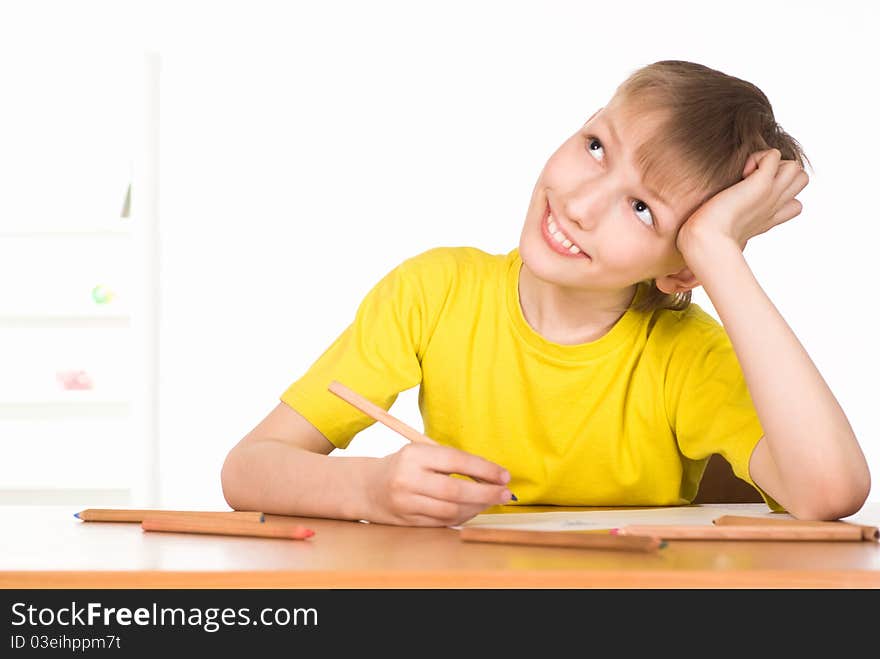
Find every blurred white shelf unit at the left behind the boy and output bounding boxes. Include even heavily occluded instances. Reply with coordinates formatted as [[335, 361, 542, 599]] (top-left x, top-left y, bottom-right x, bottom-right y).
[[0, 49, 159, 507]]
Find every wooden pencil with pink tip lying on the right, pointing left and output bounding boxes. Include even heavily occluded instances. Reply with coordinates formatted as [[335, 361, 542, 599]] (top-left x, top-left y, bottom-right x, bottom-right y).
[[612, 524, 862, 540]]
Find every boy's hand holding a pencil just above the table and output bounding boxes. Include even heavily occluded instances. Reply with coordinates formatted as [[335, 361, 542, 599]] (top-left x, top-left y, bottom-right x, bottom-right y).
[[366, 443, 510, 526]]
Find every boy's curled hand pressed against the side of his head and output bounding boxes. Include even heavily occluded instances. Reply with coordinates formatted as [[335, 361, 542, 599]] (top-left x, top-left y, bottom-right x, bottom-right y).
[[677, 149, 810, 261]]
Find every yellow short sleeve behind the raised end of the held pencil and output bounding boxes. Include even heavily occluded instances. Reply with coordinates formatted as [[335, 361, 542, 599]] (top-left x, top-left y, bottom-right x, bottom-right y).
[[281, 261, 425, 448]]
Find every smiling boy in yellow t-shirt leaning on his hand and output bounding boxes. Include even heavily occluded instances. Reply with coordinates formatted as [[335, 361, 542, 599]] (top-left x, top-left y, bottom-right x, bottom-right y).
[[222, 61, 870, 526]]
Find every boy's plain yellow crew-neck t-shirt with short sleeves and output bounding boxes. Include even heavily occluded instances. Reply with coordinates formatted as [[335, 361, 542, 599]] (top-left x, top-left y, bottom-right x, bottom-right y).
[[281, 247, 779, 509]]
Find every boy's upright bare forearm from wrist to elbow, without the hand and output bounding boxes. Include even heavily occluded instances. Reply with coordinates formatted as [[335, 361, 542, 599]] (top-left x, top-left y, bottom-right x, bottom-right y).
[[684, 239, 867, 520]]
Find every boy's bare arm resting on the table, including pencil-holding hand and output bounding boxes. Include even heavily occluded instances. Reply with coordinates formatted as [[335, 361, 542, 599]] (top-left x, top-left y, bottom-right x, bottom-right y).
[[220, 402, 511, 526]]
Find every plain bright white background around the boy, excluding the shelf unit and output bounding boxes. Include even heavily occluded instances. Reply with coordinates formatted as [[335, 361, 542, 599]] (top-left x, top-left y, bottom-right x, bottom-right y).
[[0, 0, 880, 508]]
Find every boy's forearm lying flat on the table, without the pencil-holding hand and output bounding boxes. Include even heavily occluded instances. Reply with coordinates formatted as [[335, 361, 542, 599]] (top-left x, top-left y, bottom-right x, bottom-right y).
[[221, 439, 376, 520]]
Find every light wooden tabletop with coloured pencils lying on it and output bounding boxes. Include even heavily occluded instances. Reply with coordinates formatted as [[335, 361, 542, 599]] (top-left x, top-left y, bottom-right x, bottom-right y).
[[0, 503, 880, 588]]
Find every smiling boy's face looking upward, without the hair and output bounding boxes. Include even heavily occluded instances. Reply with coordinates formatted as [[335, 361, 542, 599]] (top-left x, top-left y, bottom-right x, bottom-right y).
[[519, 100, 701, 292]]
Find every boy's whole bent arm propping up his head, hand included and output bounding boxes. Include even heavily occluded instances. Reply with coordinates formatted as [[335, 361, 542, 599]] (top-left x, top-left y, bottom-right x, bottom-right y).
[[678, 149, 870, 519]]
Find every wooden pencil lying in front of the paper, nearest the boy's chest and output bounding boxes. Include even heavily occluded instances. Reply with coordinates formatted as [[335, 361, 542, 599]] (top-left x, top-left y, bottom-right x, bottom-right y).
[[458, 526, 665, 552]]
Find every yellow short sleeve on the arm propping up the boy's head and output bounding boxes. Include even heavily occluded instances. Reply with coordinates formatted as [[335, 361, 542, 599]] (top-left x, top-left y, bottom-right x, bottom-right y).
[[669, 323, 782, 510]]
